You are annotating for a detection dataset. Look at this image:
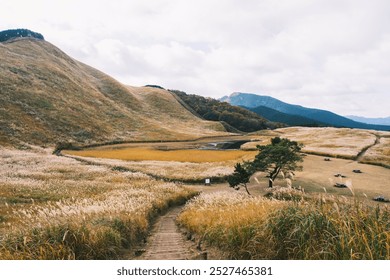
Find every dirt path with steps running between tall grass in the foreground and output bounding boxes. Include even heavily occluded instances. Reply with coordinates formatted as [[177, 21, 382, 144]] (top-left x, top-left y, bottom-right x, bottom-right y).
[[137, 207, 199, 260]]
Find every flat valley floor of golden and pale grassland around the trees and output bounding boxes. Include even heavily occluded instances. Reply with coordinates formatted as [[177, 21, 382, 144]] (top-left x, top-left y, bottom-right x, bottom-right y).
[[63, 127, 390, 200]]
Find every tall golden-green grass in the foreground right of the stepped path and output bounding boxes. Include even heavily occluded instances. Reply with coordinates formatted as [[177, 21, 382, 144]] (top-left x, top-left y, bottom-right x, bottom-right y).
[[179, 191, 390, 260]]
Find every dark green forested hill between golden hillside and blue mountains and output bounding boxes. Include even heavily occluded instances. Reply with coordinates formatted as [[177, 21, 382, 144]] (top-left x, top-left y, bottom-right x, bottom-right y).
[[170, 90, 283, 132]]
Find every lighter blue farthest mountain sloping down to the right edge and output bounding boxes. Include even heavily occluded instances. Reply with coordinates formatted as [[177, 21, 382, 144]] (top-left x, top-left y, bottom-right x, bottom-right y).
[[220, 92, 390, 130]]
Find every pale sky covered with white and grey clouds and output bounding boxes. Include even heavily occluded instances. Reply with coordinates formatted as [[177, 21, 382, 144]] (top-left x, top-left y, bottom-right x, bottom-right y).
[[0, 0, 390, 117]]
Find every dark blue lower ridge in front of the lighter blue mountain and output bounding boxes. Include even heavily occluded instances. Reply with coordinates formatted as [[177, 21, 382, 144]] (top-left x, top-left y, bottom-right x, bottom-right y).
[[243, 106, 329, 127]]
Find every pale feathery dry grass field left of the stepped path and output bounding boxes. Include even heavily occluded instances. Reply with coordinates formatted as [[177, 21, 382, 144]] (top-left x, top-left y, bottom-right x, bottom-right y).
[[0, 149, 195, 259]]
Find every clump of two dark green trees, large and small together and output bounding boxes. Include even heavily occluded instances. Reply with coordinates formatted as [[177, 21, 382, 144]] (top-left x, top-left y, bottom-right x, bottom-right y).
[[227, 137, 303, 194]]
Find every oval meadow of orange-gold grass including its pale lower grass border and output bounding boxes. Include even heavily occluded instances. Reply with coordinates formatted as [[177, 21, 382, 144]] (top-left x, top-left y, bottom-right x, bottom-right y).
[[64, 143, 256, 183]]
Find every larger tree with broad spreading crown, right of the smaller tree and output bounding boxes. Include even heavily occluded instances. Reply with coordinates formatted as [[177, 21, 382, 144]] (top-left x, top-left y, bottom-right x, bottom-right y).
[[250, 137, 303, 188]]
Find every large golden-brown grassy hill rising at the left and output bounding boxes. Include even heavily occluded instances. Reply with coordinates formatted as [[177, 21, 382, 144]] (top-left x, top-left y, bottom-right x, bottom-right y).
[[0, 37, 226, 146]]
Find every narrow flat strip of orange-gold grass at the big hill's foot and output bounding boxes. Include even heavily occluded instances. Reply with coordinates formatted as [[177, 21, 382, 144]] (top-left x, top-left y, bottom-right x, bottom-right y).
[[64, 148, 256, 163]]
